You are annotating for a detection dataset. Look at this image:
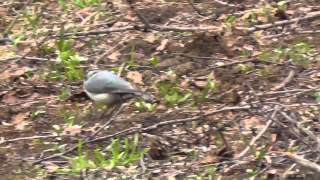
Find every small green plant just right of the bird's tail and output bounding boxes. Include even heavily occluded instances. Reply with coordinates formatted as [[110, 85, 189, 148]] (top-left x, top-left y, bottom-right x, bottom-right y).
[[158, 81, 192, 106]]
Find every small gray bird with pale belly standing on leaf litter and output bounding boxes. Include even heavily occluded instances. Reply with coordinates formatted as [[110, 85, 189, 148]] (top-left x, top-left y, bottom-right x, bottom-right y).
[[83, 70, 154, 105]]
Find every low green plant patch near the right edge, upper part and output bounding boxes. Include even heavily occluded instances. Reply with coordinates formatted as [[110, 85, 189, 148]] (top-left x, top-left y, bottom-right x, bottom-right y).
[[260, 42, 315, 67]]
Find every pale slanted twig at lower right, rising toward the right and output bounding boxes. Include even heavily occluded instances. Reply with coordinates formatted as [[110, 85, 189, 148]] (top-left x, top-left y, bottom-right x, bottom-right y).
[[236, 105, 279, 159]]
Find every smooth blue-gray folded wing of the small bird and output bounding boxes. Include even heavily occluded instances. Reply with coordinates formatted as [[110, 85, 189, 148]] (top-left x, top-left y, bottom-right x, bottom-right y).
[[84, 71, 136, 93]]
